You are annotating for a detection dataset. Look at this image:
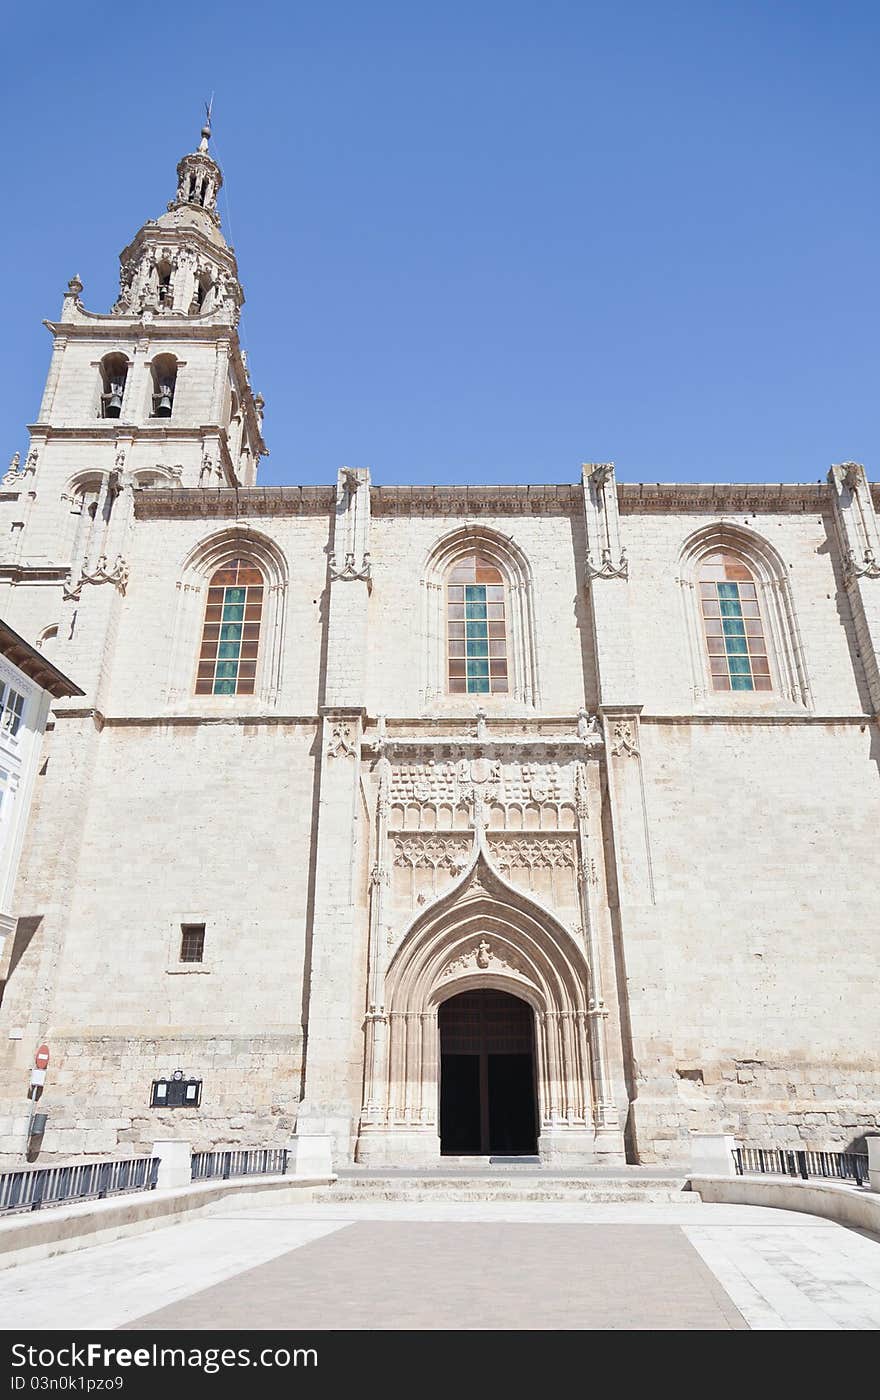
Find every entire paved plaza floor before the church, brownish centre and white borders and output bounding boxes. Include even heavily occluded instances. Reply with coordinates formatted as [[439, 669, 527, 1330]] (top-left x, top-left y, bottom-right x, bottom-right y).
[[0, 1201, 880, 1331]]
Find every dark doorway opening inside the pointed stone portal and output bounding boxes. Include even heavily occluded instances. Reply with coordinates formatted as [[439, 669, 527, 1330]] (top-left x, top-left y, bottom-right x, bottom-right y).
[[438, 991, 537, 1156]]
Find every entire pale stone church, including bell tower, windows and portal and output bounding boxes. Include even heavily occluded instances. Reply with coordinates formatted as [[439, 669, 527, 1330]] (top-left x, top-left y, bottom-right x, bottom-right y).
[[0, 130, 880, 1165]]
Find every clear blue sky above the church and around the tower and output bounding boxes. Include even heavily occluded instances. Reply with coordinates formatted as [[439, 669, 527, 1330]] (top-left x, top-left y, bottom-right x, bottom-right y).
[[0, 0, 880, 484]]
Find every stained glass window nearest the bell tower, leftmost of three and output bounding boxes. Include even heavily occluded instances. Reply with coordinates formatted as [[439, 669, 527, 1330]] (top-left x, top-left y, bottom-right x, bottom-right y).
[[196, 559, 263, 696]]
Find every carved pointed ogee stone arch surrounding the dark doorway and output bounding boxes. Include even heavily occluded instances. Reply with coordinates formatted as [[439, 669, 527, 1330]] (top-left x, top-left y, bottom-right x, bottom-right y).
[[357, 833, 618, 1165]]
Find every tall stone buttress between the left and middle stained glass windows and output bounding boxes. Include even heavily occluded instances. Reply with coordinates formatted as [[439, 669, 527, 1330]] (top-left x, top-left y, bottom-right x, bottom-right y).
[[297, 468, 371, 1162]]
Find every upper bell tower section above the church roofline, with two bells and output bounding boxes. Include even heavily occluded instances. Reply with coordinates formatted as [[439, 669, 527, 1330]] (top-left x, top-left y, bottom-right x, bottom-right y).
[[21, 125, 266, 506]]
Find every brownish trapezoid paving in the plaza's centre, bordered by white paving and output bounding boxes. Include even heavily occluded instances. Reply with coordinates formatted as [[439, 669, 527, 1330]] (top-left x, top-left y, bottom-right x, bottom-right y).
[[130, 1221, 746, 1331]]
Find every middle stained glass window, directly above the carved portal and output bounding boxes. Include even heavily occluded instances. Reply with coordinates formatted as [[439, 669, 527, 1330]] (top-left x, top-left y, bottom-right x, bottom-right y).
[[446, 554, 508, 694]]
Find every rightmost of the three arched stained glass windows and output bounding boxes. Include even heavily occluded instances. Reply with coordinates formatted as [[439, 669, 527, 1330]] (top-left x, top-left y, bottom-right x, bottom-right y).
[[700, 550, 772, 690]]
